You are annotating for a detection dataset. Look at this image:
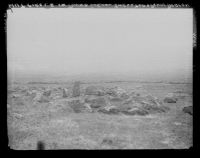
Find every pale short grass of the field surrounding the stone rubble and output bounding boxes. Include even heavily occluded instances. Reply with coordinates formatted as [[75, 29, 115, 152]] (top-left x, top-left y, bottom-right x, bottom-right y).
[[8, 82, 193, 150]]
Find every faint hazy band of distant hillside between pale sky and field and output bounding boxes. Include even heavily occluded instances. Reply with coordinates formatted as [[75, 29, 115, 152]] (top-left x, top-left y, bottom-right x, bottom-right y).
[[8, 70, 192, 83]]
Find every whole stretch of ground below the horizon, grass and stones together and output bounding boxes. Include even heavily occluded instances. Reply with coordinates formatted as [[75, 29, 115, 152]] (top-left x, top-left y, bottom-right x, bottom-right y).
[[7, 82, 193, 150]]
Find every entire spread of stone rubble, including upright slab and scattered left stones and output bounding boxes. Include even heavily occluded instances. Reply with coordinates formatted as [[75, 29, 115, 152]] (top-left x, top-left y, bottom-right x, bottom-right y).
[[9, 81, 169, 115]]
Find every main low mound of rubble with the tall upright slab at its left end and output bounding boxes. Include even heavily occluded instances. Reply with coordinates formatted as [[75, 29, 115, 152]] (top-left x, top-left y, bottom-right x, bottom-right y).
[[62, 83, 169, 115]]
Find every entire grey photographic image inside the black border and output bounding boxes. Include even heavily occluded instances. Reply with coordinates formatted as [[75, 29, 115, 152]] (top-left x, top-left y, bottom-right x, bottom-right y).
[[6, 5, 193, 150]]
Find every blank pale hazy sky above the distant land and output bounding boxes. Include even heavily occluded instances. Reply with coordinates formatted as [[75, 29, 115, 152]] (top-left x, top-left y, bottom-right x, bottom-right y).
[[7, 8, 193, 79]]
